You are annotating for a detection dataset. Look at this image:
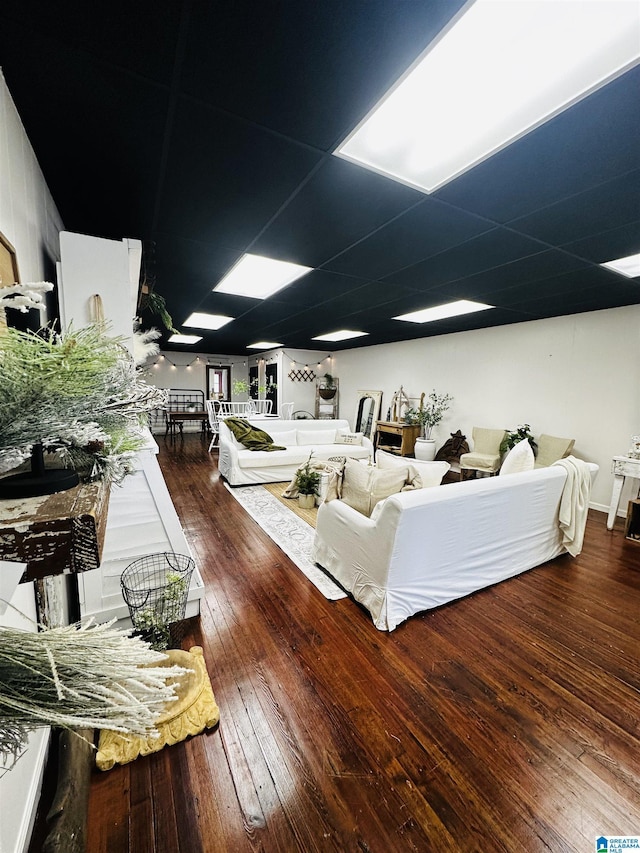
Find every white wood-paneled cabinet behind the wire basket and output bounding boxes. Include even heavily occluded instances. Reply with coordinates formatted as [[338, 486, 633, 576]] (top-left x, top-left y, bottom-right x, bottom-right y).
[[77, 439, 204, 624]]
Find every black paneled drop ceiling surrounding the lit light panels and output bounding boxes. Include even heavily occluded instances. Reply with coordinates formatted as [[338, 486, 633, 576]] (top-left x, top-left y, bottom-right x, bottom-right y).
[[0, 0, 640, 354]]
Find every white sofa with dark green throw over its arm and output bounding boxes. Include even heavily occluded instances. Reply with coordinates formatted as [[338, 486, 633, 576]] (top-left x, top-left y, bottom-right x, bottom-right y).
[[218, 418, 373, 486]]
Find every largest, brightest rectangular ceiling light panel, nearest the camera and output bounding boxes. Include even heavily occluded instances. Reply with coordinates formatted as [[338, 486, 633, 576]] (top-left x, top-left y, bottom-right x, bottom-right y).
[[334, 0, 640, 192]]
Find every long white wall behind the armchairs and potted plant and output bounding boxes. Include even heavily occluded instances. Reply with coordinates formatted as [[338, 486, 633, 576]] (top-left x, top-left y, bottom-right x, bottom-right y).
[[334, 305, 640, 509]]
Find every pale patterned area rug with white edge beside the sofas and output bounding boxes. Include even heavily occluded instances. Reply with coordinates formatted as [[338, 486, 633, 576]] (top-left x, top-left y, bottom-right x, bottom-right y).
[[224, 483, 347, 601]]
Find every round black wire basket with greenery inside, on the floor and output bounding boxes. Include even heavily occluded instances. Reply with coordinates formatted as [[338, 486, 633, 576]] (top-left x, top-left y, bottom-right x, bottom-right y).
[[120, 553, 196, 649]]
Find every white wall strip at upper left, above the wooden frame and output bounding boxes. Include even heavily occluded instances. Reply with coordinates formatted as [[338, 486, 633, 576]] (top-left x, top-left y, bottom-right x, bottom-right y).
[[0, 71, 63, 302]]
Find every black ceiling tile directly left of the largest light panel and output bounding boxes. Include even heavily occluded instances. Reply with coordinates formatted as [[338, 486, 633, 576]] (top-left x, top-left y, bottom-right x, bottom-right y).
[[180, 0, 464, 151]]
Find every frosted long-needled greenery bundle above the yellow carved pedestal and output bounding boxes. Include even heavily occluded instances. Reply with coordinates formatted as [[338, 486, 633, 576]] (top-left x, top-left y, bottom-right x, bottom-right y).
[[0, 620, 188, 767]]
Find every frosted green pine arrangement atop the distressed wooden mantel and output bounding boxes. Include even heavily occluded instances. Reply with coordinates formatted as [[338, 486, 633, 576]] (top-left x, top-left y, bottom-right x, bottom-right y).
[[0, 325, 166, 481]]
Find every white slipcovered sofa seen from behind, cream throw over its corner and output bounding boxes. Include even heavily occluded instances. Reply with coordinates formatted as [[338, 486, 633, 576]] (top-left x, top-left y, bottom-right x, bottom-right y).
[[312, 464, 598, 631]]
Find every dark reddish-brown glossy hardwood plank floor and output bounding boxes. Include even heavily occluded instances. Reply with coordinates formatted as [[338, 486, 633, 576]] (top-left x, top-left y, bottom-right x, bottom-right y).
[[87, 435, 640, 853]]
